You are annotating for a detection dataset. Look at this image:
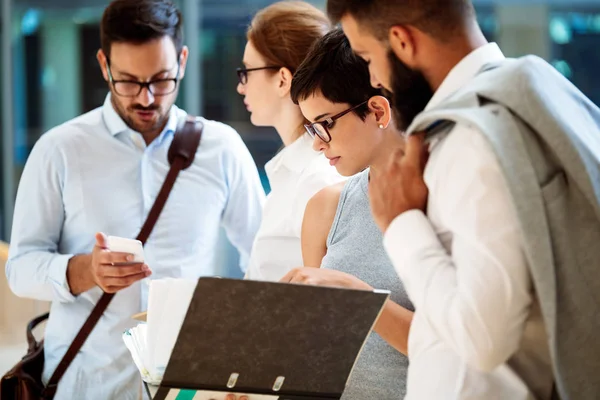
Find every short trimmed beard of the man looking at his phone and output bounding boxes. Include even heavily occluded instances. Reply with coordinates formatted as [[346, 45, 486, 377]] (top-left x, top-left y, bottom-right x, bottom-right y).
[[111, 88, 177, 135]]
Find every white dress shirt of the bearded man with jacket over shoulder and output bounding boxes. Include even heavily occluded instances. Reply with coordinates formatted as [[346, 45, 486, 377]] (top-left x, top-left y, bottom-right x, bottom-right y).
[[384, 43, 552, 400]]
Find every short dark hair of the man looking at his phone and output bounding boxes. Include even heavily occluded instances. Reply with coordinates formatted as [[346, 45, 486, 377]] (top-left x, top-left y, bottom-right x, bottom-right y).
[[100, 0, 183, 57]]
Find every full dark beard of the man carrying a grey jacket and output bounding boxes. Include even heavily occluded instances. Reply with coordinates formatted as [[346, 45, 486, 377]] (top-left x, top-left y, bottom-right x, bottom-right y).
[[384, 50, 433, 132]]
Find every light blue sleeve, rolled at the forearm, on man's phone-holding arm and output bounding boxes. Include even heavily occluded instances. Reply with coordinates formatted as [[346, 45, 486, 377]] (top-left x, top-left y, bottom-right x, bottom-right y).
[[6, 135, 75, 302]]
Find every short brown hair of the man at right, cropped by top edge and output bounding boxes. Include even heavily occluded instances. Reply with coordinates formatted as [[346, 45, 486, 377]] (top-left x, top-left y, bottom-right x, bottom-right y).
[[327, 0, 475, 41]]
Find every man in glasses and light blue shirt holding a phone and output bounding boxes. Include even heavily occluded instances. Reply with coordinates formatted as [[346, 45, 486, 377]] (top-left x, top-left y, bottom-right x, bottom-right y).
[[6, 0, 264, 400]]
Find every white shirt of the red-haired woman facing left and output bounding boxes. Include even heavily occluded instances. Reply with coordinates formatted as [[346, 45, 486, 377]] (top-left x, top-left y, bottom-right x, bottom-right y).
[[246, 134, 346, 281]]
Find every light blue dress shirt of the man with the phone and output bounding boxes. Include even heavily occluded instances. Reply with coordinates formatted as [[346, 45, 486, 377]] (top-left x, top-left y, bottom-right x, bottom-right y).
[[6, 95, 265, 400]]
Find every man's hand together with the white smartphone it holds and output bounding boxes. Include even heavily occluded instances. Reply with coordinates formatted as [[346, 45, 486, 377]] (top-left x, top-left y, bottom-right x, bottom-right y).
[[91, 233, 152, 293]]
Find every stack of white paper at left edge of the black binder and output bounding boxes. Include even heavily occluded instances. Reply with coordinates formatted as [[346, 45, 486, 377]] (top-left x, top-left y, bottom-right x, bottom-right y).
[[123, 278, 198, 385]]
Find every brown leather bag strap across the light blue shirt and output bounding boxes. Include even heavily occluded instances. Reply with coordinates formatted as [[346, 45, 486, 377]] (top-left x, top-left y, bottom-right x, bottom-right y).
[[43, 116, 204, 399]]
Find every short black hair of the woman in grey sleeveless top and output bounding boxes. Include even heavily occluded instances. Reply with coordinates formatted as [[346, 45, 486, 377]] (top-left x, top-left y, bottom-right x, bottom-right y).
[[291, 29, 381, 119]]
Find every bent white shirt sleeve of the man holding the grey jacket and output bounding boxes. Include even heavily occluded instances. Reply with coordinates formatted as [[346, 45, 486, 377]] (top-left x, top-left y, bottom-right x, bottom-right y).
[[384, 127, 531, 371]]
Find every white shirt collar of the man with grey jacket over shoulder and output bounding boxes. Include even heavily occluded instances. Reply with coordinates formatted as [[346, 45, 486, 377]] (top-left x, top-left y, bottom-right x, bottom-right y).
[[425, 43, 504, 110]]
